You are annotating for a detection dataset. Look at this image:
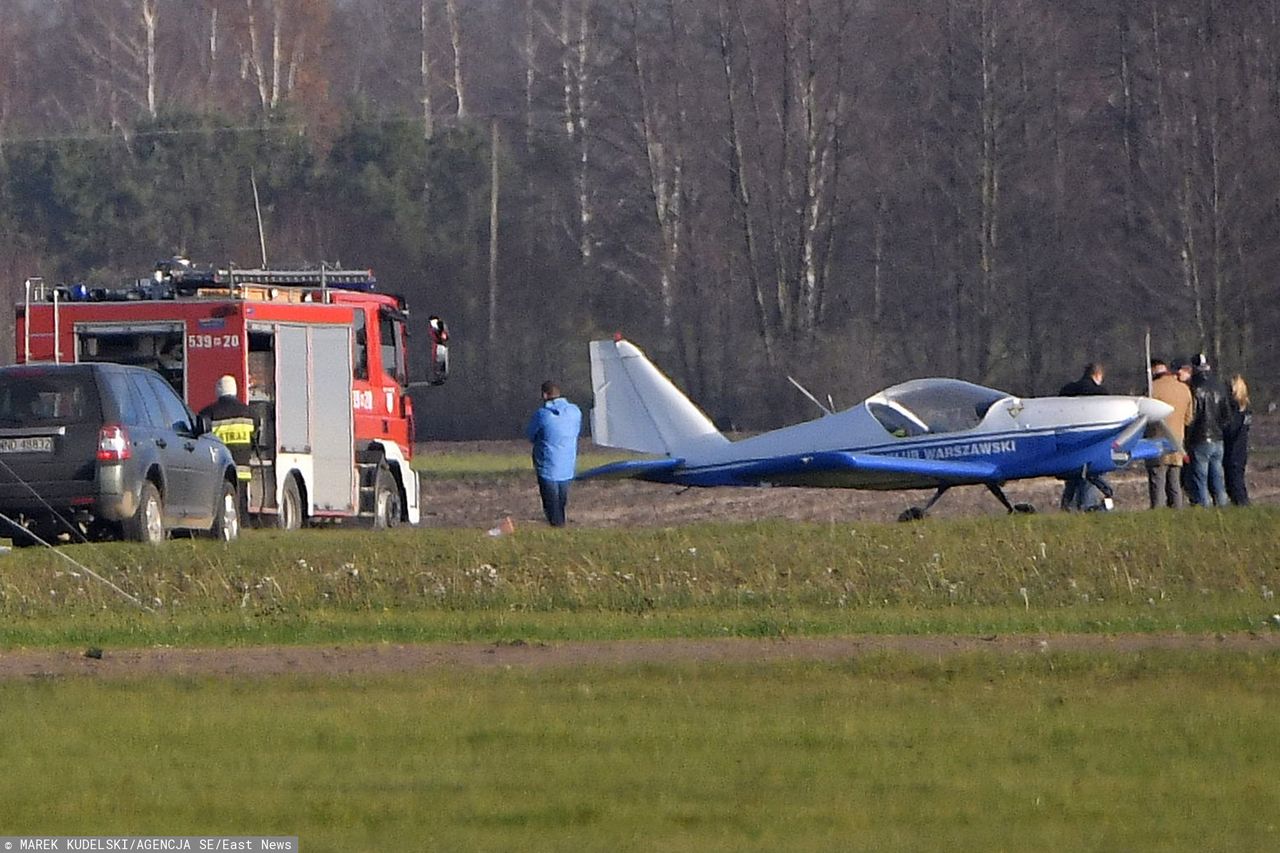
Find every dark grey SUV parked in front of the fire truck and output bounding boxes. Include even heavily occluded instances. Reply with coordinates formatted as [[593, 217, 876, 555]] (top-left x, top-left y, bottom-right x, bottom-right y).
[[0, 364, 239, 544]]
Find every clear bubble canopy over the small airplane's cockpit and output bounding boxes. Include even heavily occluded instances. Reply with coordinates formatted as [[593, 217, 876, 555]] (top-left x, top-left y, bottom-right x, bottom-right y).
[[867, 379, 1010, 438]]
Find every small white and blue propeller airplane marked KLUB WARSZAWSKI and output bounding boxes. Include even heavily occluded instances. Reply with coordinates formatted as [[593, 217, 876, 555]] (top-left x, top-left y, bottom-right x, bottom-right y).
[[577, 337, 1174, 520]]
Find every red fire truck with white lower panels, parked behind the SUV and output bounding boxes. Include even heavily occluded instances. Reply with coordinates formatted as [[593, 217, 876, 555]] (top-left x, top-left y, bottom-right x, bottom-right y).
[[14, 259, 448, 529]]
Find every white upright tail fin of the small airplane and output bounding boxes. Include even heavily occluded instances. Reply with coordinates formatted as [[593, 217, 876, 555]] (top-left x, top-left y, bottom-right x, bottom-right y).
[[590, 341, 728, 456]]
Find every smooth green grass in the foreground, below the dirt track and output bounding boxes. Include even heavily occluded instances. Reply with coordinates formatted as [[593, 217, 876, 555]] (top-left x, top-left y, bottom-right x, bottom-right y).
[[0, 653, 1280, 850]]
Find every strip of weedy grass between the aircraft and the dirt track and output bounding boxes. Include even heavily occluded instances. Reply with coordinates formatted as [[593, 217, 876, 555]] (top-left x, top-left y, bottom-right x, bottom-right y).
[[0, 507, 1280, 648]]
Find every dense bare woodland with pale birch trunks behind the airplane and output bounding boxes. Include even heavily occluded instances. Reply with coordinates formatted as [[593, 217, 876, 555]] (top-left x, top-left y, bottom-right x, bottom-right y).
[[0, 0, 1280, 438]]
